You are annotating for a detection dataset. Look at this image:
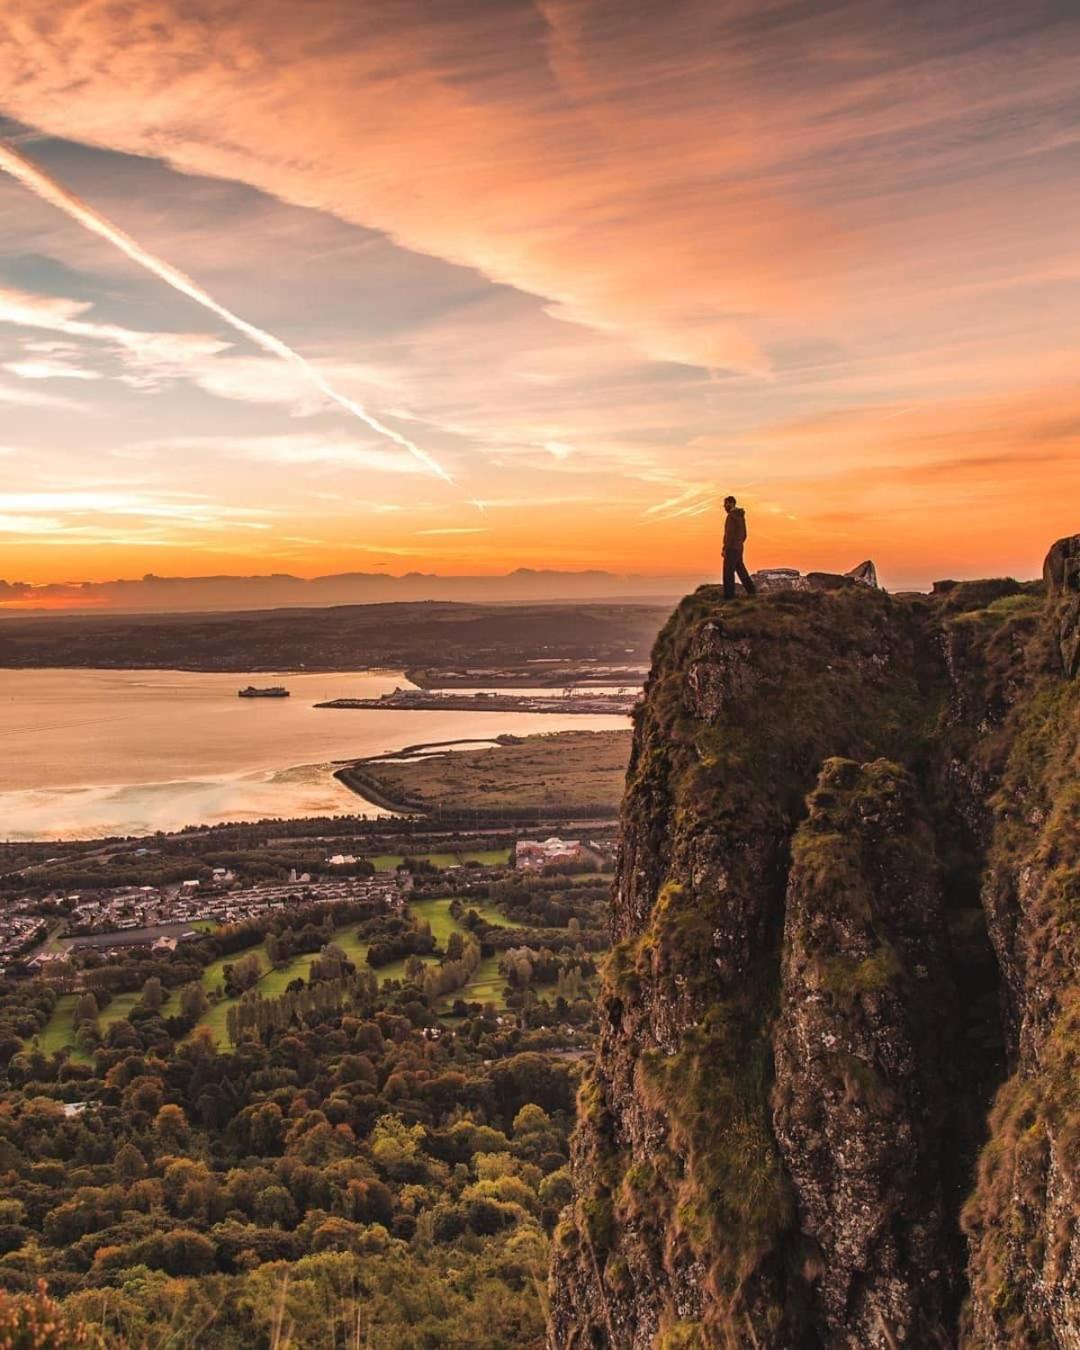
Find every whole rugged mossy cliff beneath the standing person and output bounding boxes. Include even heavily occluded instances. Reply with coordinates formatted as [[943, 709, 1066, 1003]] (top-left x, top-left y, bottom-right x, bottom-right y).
[[549, 539, 1080, 1350]]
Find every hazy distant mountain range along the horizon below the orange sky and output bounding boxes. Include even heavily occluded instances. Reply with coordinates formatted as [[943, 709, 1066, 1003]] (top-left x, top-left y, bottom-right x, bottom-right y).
[[0, 567, 716, 613]]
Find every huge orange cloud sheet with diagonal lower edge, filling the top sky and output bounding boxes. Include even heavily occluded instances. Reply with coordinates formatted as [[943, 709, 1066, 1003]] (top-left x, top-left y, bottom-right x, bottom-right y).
[[0, 0, 1077, 386]]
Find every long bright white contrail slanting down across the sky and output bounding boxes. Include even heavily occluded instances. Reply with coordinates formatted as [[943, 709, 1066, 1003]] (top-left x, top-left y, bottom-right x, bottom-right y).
[[0, 140, 452, 483]]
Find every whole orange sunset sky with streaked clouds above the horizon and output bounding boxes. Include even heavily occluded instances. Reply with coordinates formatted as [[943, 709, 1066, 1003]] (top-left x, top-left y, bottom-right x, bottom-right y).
[[0, 0, 1080, 603]]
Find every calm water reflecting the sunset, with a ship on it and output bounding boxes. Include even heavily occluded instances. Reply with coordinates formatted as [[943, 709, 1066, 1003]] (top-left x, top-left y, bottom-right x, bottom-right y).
[[0, 670, 629, 840]]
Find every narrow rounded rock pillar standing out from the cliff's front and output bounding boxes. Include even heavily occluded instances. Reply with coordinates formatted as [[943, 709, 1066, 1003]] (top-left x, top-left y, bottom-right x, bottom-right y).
[[774, 760, 957, 1347]]
